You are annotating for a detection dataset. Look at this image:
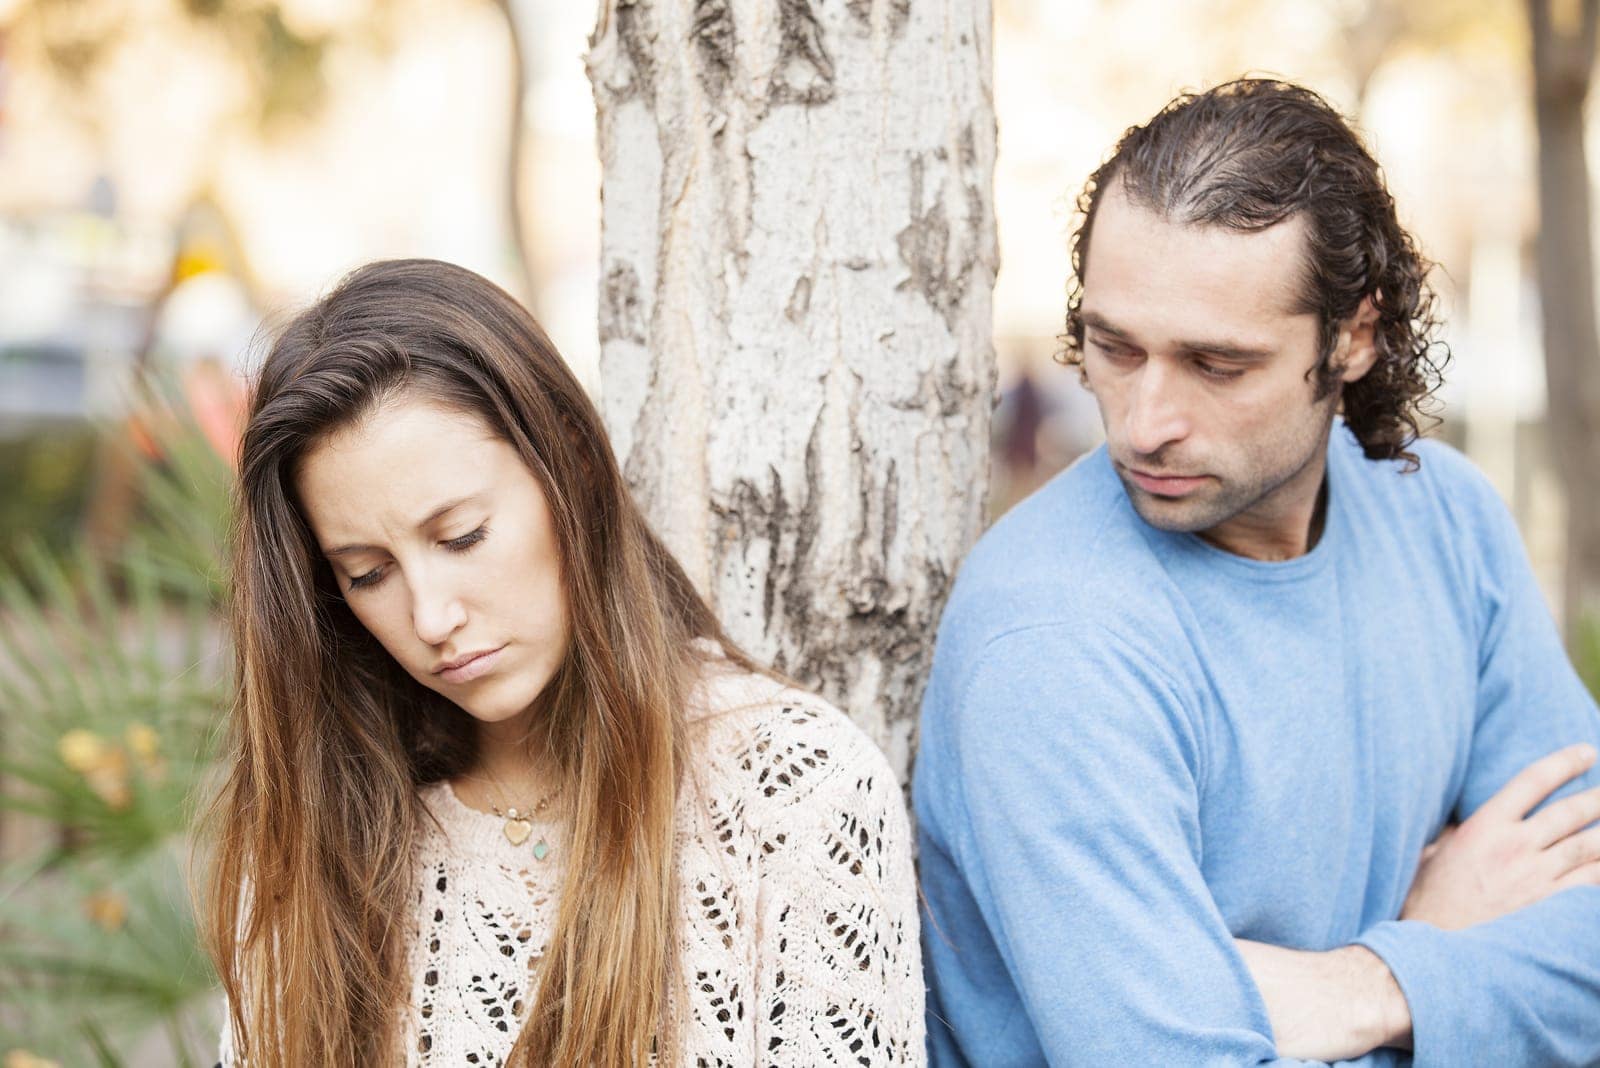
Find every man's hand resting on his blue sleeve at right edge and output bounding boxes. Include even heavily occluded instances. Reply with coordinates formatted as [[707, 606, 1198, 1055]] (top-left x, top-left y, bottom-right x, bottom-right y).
[[1400, 745, 1600, 929]]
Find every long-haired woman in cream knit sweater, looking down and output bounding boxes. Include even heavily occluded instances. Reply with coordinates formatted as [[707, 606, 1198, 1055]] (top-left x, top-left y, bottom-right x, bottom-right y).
[[205, 261, 923, 1068]]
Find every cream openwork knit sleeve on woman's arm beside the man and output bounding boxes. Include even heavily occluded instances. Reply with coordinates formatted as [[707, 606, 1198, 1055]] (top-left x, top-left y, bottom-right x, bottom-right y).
[[754, 708, 926, 1068]]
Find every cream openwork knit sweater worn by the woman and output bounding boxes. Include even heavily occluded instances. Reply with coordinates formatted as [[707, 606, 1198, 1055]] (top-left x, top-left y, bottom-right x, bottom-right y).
[[222, 662, 925, 1068]]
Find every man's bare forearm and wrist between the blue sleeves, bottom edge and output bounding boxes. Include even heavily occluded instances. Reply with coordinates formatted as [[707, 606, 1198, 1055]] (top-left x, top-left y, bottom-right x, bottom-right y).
[[1235, 938, 1411, 1062]]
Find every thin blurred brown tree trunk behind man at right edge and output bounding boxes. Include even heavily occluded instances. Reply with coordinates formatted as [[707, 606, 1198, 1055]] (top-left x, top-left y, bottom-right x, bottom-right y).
[[1528, 0, 1600, 640]]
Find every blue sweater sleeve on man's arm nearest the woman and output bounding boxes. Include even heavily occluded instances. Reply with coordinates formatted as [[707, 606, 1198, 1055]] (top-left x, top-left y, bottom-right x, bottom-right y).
[[917, 625, 1324, 1066]]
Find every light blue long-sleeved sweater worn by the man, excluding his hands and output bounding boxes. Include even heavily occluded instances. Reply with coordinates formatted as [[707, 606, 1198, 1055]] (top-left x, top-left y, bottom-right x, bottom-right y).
[[914, 425, 1600, 1068]]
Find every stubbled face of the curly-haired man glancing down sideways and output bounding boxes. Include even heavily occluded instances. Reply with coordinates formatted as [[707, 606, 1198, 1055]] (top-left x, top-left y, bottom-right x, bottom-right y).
[[1082, 182, 1371, 558]]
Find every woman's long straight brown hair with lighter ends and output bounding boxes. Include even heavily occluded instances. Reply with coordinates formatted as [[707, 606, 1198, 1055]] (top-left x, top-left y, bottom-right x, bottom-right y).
[[202, 259, 752, 1068]]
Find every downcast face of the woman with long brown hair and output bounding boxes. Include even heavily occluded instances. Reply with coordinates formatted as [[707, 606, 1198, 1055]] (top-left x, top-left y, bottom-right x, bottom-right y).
[[294, 393, 568, 727]]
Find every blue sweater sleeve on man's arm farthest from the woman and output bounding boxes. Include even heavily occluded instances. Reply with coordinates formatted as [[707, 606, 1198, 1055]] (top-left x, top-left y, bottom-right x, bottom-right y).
[[1360, 488, 1600, 1068]]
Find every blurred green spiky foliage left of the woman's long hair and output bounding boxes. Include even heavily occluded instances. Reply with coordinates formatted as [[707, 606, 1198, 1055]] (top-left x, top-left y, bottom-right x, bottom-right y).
[[0, 383, 230, 1065]]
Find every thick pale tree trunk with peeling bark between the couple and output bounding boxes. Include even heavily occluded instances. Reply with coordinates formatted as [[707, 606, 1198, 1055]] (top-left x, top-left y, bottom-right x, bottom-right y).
[[589, 0, 997, 775]]
